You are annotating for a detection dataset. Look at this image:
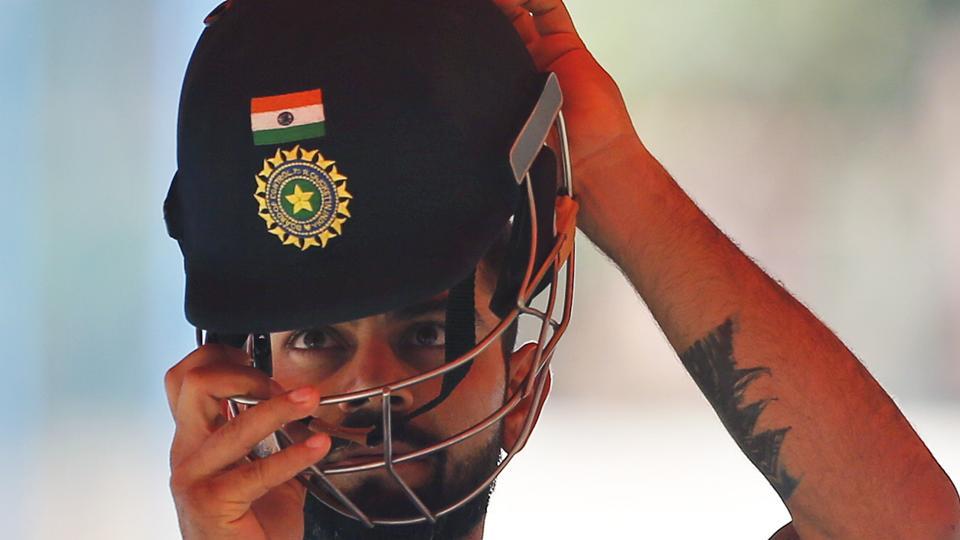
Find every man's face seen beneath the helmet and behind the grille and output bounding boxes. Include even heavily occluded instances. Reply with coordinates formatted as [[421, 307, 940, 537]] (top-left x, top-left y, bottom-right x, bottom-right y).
[[271, 268, 529, 519]]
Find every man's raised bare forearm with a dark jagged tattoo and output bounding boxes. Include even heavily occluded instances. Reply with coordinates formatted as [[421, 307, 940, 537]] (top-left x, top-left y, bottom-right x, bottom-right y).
[[579, 137, 960, 538]]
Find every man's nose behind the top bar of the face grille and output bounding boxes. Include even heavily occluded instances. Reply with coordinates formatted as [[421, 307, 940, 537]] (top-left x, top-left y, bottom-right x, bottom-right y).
[[338, 344, 416, 414]]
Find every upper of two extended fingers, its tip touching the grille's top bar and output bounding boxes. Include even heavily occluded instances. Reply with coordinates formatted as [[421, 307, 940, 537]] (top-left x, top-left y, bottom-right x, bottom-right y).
[[183, 387, 320, 476]]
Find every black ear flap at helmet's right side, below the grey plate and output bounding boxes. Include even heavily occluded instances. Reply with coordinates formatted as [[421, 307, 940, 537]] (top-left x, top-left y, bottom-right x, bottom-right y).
[[490, 145, 559, 319]]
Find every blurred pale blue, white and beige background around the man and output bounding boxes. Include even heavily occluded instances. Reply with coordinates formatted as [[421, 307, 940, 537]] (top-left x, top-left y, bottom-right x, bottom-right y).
[[0, 0, 960, 539]]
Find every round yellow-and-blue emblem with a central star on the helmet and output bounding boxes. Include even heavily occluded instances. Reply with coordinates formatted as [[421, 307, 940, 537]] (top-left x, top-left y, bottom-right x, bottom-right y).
[[254, 145, 353, 251]]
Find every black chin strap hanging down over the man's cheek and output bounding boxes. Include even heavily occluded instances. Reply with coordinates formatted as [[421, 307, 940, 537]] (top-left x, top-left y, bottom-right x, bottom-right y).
[[406, 271, 477, 420]]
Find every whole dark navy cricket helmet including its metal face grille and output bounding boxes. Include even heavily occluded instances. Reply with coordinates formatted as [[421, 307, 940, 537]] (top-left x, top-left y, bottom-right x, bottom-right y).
[[164, 0, 576, 526]]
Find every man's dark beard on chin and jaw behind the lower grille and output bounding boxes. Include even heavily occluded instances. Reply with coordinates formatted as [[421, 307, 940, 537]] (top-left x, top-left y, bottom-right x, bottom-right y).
[[303, 429, 501, 540]]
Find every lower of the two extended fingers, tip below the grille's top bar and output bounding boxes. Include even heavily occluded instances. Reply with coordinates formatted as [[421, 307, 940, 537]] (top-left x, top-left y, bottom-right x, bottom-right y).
[[212, 433, 330, 502]]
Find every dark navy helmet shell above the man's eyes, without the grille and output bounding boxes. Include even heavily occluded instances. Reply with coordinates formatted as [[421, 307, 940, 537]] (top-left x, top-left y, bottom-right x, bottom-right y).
[[164, 0, 542, 333]]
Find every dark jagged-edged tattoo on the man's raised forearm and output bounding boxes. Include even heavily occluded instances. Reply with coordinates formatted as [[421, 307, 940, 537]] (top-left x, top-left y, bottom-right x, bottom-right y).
[[680, 319, 799, 502]]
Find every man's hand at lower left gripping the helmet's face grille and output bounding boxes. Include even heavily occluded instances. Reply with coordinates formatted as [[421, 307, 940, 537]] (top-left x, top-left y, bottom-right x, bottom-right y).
[[165, 345, 330, 540]]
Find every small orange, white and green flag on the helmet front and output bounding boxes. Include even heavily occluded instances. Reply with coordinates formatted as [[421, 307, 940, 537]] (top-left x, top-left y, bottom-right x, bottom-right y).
[[250, 88, 326, 146]]
